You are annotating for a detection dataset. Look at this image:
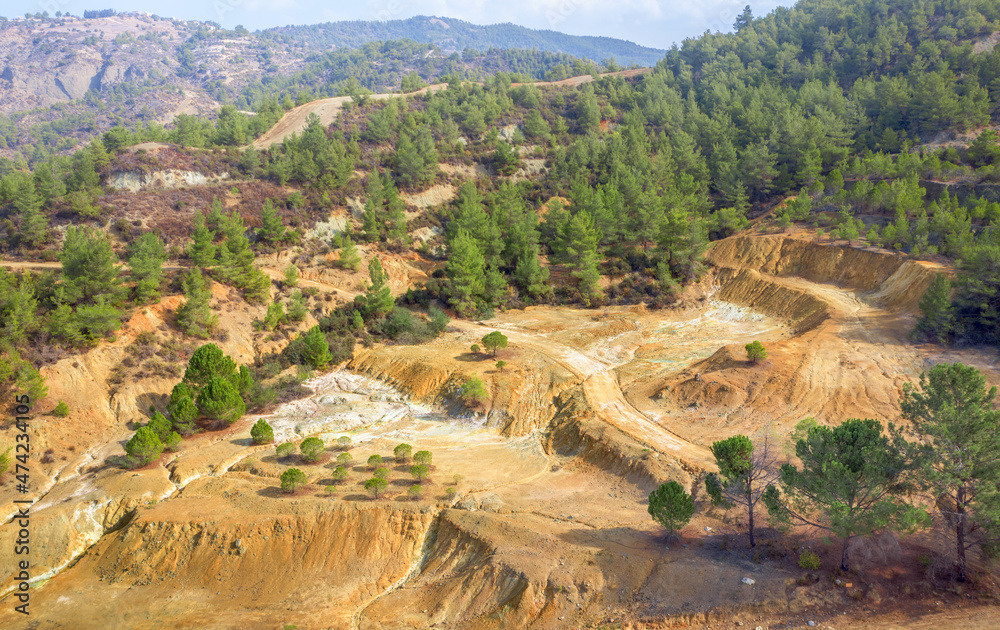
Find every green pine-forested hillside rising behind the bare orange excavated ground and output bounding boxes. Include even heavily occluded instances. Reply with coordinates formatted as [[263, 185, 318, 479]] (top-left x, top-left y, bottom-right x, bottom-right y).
[[0, 0, 1000, 400]]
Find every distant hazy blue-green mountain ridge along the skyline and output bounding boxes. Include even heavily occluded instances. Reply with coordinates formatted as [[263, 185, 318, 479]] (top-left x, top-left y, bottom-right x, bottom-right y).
[[260, 15, 666, 66]]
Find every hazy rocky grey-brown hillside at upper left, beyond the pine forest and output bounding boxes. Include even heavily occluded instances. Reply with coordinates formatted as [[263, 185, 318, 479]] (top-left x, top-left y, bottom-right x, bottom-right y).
[[0, 13, 616, 163]]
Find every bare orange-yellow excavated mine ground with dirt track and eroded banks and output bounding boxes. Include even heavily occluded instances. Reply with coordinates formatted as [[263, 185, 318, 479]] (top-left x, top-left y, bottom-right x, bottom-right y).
[[0, 236, 1000, 630]]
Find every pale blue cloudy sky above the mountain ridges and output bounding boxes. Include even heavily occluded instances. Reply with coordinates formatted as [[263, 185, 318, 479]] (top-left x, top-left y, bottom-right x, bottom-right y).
[[0, 0, 792, 48]]
